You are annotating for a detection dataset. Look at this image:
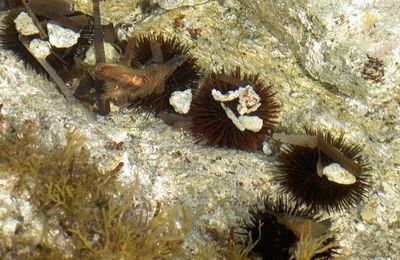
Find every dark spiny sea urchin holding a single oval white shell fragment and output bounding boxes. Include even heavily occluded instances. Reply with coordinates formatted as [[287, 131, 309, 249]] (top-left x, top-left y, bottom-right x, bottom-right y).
[[276, 131, 369, 212]]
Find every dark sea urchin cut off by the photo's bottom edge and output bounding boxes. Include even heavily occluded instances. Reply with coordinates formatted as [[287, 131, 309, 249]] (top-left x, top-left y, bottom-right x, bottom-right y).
[[242, 197, 338, 260]]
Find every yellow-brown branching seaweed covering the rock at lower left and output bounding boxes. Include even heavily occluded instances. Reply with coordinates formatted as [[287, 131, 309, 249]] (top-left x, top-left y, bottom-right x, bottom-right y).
[[0, 123, 190, 259]]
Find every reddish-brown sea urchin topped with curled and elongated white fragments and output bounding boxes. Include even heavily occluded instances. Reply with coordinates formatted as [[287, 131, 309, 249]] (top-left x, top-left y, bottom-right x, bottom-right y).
[[190, 67, 279, 151]]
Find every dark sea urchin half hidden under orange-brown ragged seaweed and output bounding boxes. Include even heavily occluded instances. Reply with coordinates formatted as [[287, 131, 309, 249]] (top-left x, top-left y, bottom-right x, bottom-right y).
[[125, 34, 201, 114]]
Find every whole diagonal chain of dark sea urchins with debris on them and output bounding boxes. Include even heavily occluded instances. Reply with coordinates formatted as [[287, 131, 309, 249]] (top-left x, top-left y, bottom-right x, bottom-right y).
[[0, 0, 369, 259]]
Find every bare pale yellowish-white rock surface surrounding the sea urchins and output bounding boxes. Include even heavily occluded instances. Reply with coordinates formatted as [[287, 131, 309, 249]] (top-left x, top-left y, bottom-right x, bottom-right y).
[[0, 0, 400, 259]]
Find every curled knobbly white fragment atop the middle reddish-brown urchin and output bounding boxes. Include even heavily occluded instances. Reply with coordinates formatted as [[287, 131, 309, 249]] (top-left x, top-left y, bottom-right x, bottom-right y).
[[211, 85, 261, 115]]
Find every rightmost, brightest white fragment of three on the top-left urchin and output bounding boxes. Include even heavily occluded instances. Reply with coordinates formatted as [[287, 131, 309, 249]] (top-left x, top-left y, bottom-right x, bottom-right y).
[[47, 23, 80, 48]]
